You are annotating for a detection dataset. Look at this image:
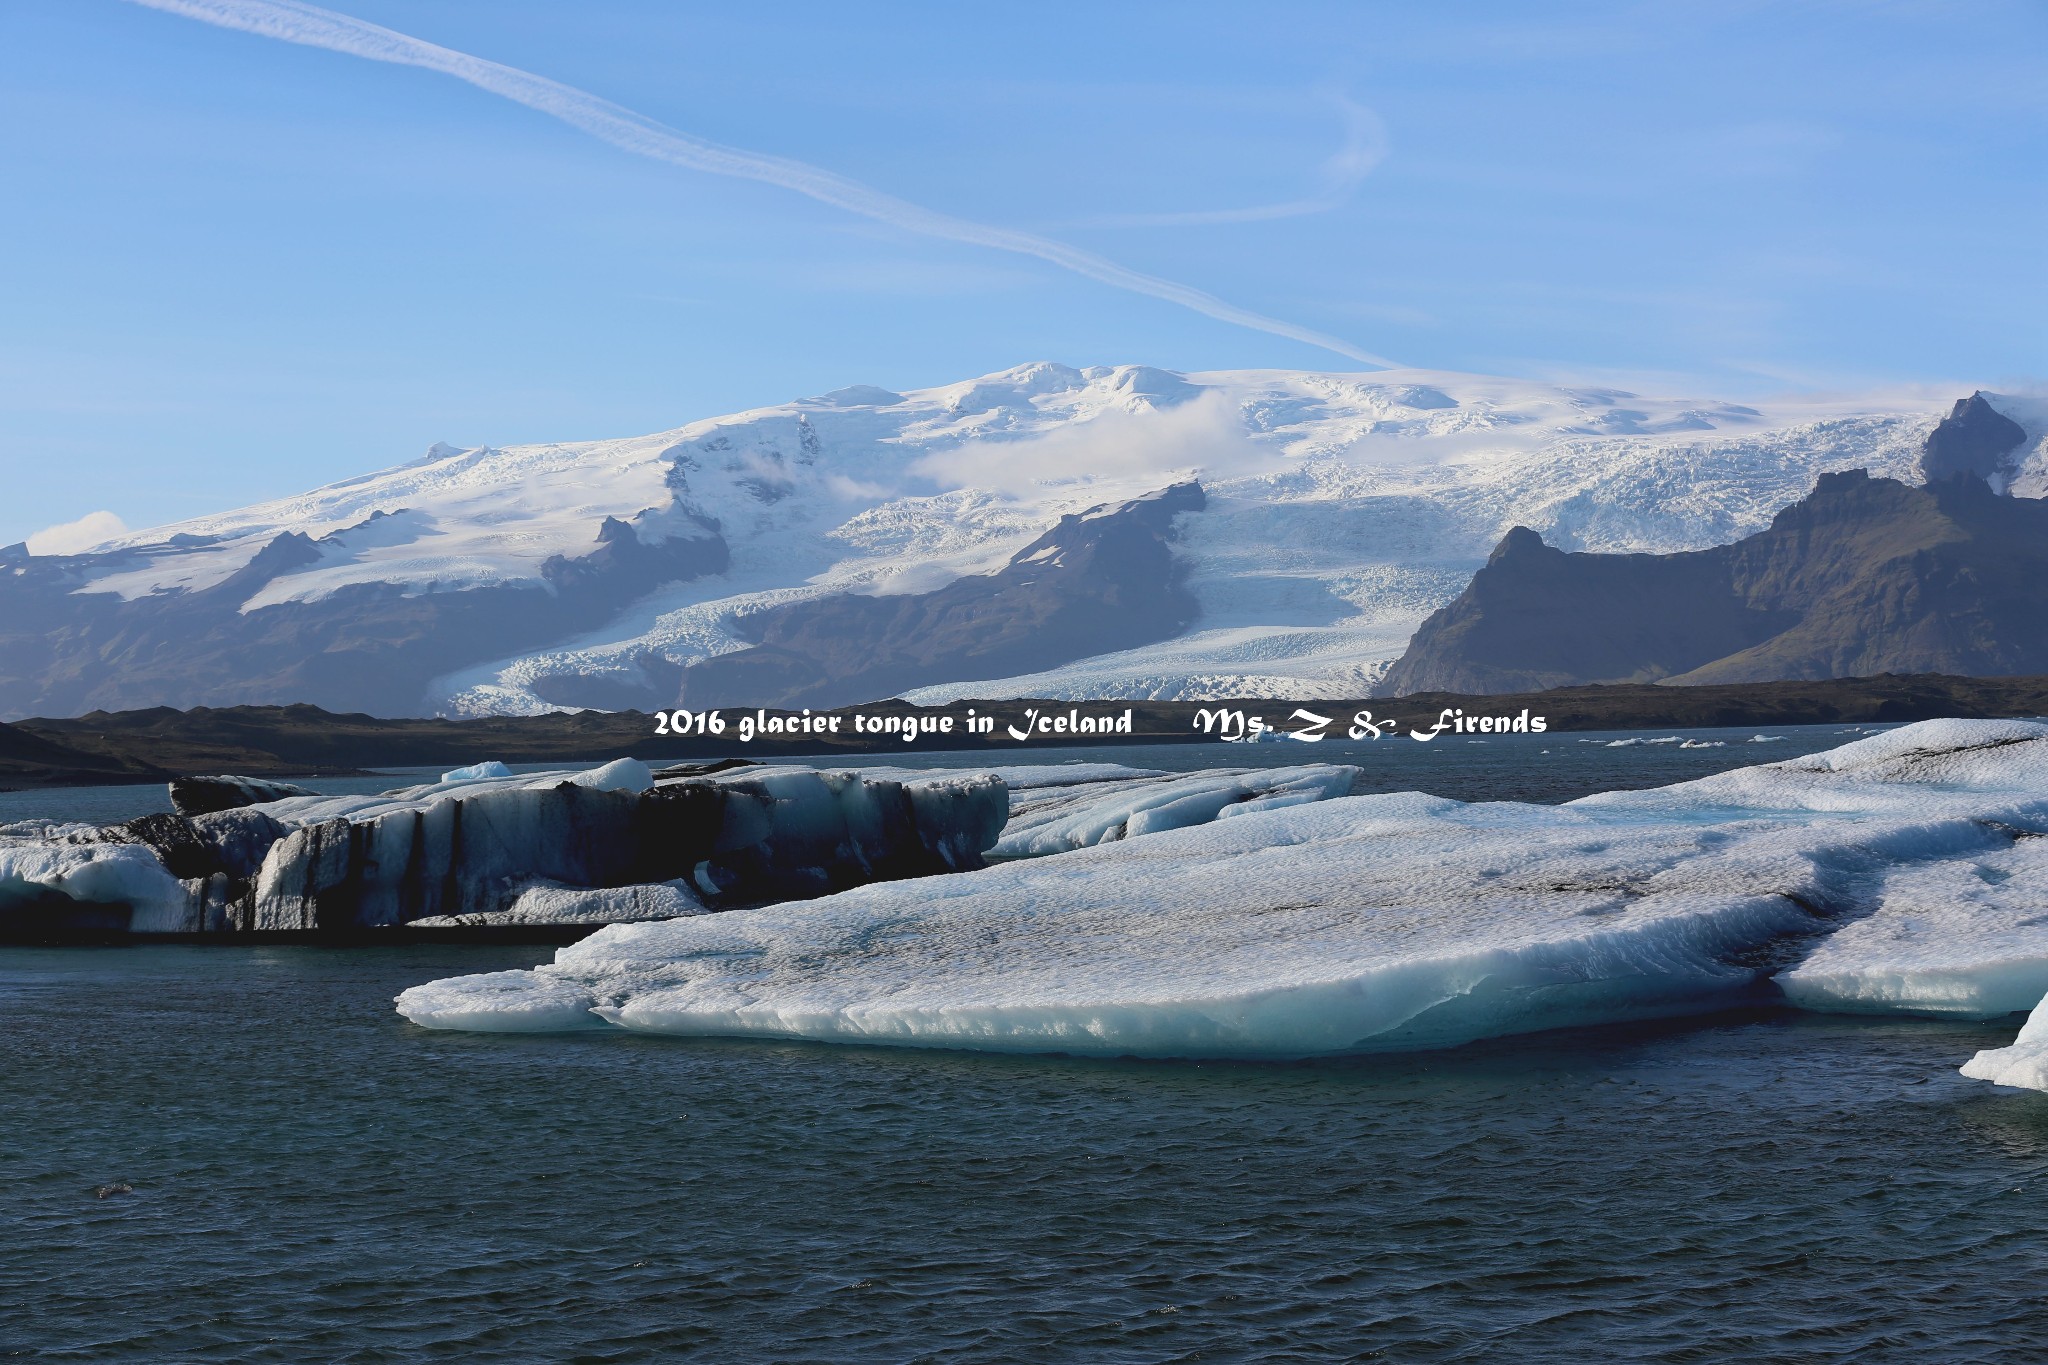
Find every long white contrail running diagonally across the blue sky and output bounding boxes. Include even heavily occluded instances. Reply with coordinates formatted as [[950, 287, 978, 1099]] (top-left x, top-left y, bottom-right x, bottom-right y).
[[112, 0, 1399, 368]]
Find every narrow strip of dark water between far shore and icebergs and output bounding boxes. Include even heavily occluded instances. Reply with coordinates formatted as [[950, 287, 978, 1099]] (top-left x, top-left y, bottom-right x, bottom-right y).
[[0, 716, 1888, 825]]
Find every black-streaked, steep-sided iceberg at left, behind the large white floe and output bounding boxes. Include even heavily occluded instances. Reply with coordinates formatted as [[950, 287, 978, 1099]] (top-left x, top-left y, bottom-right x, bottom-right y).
[[0, 759, 1008, 933]]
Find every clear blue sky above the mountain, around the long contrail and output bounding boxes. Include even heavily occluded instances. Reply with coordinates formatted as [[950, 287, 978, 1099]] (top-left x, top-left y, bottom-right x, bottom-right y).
[[0, 0, 2048, 544]]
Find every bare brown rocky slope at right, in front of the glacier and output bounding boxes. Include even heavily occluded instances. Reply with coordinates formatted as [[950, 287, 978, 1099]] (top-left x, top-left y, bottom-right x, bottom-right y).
[[1384, 471, 2048, 694]]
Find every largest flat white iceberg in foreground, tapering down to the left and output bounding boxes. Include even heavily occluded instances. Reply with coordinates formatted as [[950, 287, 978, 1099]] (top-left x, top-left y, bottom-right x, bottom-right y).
[[399, 720, 2048, 1058]]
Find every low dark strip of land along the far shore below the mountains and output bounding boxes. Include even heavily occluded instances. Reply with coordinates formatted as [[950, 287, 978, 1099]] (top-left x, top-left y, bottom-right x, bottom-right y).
[[0, 673, 2048, 790]]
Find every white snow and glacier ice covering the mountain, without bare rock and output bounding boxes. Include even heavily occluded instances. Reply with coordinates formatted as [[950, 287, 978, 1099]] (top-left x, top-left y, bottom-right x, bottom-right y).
[[82, 362, 2048, 714]]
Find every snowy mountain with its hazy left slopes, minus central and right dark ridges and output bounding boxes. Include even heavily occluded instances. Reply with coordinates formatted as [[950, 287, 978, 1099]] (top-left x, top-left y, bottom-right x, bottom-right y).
[[0, 364, 2048, 714]]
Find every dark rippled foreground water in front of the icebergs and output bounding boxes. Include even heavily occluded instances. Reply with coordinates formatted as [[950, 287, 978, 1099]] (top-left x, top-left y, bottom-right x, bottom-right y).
[[0, 945, 2048, 1361]]
